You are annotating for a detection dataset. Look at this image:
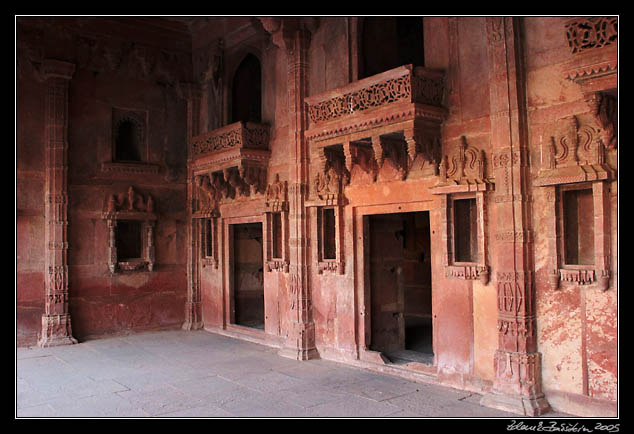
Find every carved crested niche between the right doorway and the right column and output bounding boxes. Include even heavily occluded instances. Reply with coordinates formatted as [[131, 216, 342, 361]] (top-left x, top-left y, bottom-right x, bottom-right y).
[[430, 137, 495, 285]]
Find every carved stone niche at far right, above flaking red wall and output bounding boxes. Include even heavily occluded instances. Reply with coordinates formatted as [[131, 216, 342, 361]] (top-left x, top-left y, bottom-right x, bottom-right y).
[[534, 115, 616, 291]]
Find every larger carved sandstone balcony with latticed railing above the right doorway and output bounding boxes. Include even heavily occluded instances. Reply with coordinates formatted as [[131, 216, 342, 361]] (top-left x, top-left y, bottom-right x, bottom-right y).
[[306, 65, 447, 182]]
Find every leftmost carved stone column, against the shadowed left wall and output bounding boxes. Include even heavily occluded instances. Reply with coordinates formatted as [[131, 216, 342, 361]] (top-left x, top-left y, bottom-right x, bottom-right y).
[[38, 59, 77, 347]]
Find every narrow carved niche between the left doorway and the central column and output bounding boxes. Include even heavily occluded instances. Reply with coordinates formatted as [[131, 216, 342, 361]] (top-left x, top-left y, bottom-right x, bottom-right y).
[[264, 174, 290, 273]]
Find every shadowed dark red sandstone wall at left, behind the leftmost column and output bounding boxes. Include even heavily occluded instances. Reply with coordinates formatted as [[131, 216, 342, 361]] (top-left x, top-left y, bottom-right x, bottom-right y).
[[17, 18, 191, 344]]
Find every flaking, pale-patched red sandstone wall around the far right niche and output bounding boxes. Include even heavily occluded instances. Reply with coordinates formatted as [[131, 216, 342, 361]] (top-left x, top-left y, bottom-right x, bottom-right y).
[[524, 18, 618, 415]]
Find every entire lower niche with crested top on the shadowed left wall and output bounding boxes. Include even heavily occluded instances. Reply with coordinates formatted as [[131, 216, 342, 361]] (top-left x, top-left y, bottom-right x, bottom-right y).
[[102, 186, 157, 273]]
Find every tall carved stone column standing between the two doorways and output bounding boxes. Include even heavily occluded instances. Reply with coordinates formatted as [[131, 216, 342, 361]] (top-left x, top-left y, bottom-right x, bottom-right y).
[[280, 19, 318, 360]]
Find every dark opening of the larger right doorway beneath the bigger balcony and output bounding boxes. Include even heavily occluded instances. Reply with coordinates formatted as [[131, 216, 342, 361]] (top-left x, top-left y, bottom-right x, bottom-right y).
[[368, 211, 434, 364]]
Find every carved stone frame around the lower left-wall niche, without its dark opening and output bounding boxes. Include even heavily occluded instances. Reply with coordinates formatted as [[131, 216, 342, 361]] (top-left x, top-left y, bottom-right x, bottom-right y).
[[101, 186, 157, 273]]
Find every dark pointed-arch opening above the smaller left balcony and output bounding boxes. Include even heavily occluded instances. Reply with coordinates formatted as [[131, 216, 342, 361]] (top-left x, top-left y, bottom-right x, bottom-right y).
[[230, 53, 262, 123]]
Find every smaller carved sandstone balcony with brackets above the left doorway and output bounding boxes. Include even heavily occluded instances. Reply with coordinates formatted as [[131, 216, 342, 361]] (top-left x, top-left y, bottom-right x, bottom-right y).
[[189, 122, 271, 208]]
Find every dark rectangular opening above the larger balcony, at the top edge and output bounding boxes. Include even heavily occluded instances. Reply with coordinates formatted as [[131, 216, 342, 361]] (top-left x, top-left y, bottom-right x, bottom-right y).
[[358, 17, 425, 79]]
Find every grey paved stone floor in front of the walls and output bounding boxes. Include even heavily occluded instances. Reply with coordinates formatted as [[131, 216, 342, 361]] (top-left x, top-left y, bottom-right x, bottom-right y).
[[15, 330, 558, 418]]
